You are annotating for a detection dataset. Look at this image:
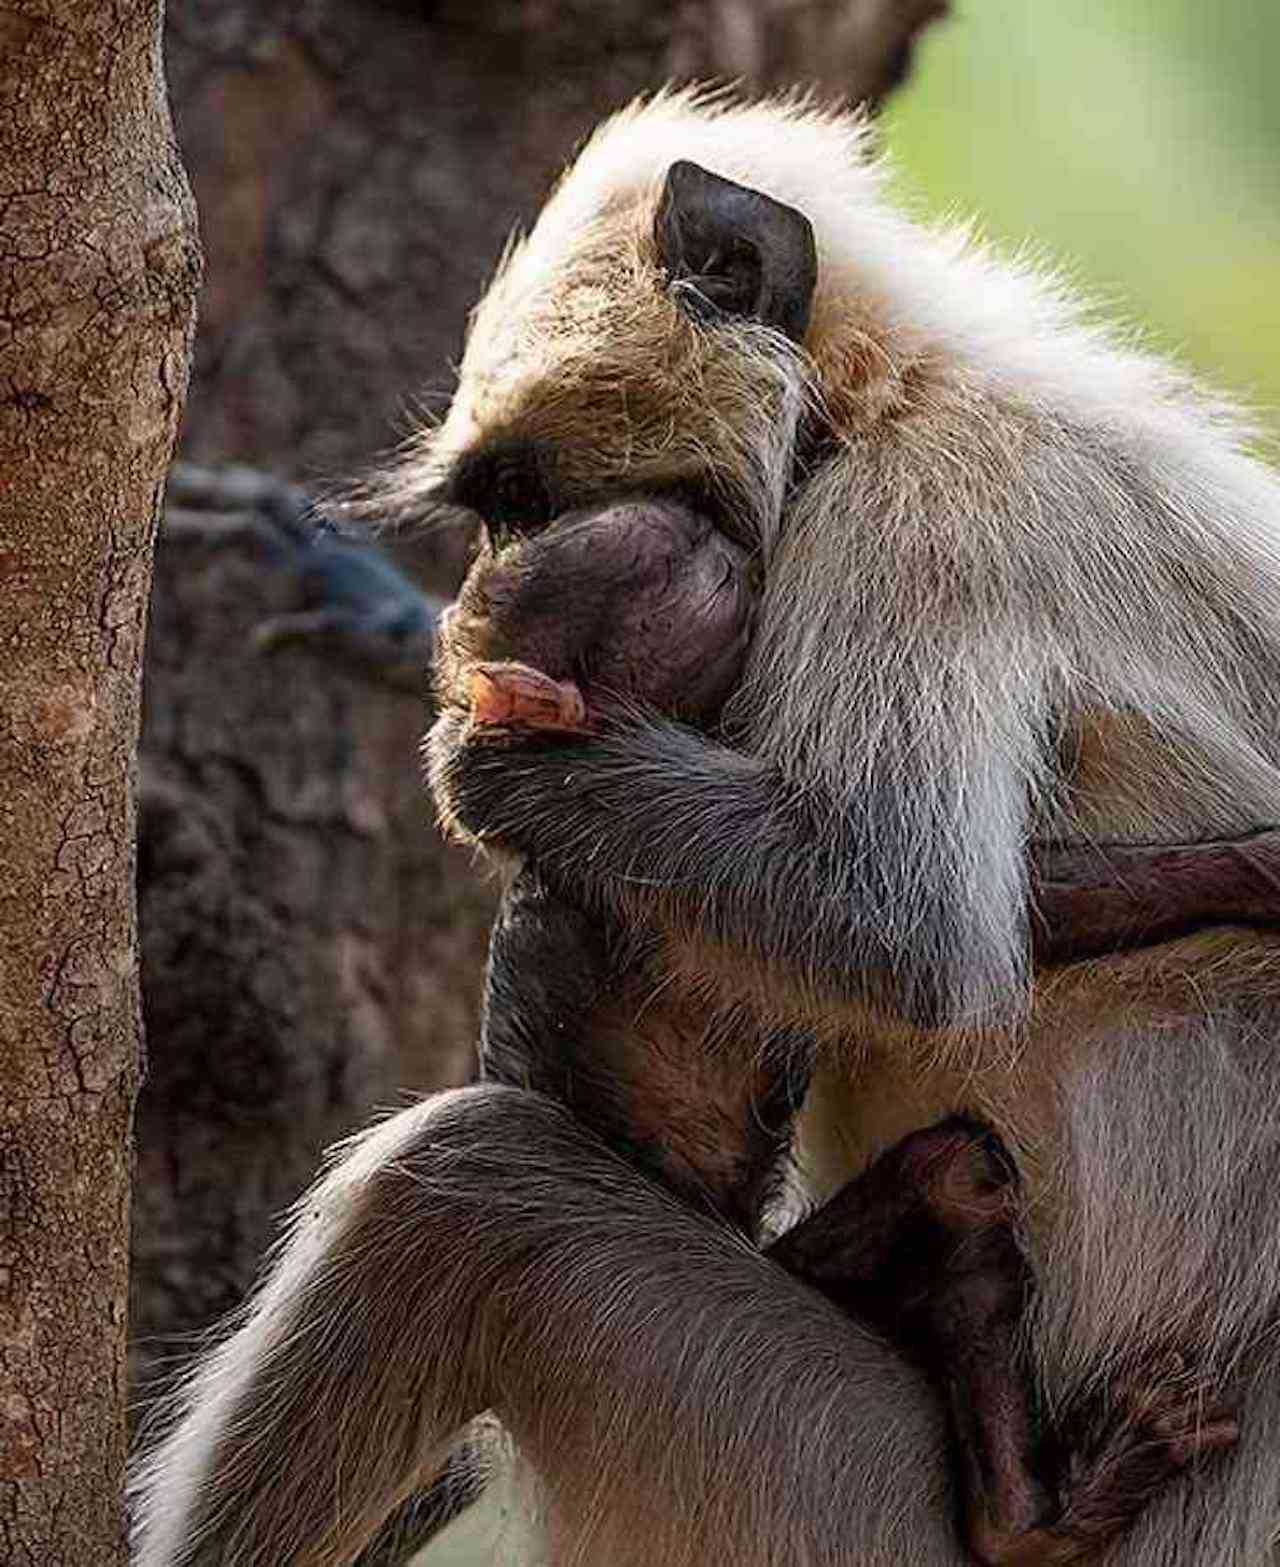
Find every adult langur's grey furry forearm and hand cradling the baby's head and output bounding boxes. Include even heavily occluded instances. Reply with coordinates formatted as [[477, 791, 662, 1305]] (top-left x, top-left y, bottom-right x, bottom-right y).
[[428, 715, 927, 1015]]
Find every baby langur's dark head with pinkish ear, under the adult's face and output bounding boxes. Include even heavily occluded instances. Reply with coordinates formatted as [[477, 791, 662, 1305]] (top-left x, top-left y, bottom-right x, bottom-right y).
[[437, 497, 755, 730]]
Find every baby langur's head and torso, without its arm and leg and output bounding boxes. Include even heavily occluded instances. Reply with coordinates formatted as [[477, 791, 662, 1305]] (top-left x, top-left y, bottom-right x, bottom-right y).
[[436, 498, 789, 1233]]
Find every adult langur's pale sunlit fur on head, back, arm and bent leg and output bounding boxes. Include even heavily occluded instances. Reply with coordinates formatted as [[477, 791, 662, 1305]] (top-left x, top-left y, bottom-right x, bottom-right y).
[[138, 94, 1280, 1567]]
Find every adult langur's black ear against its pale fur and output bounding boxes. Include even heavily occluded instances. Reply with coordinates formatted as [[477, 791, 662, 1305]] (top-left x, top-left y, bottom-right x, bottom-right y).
[[653, 161, 818, 342]]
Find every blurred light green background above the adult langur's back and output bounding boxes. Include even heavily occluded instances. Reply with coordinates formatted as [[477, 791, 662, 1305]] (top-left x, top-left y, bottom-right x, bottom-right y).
[[885, 0, 1280, 434]]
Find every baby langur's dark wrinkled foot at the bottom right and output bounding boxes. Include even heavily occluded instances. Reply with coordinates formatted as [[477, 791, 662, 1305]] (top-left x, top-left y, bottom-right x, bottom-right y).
[[970, 1357, 1239, 1567]]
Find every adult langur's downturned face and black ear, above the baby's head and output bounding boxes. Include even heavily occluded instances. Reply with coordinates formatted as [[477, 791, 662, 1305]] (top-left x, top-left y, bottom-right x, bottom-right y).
[[426, 161, 816, 560]]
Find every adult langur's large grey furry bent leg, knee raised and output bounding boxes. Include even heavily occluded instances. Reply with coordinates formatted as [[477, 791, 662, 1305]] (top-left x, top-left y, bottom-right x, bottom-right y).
[[135, 1086, 960, 1567]]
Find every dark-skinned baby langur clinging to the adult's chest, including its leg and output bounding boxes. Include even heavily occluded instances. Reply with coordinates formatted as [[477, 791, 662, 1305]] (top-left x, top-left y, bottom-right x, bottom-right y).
[[439, 498, 1236, 1562]]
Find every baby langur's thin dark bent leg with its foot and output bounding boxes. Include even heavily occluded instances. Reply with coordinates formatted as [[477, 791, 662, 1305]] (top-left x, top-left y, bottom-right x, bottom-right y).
[[771, 1119, 1238, 1567]]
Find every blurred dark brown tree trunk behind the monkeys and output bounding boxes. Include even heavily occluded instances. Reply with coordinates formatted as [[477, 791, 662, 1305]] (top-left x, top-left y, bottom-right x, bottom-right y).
[[133, 0, 943, 1371]]
